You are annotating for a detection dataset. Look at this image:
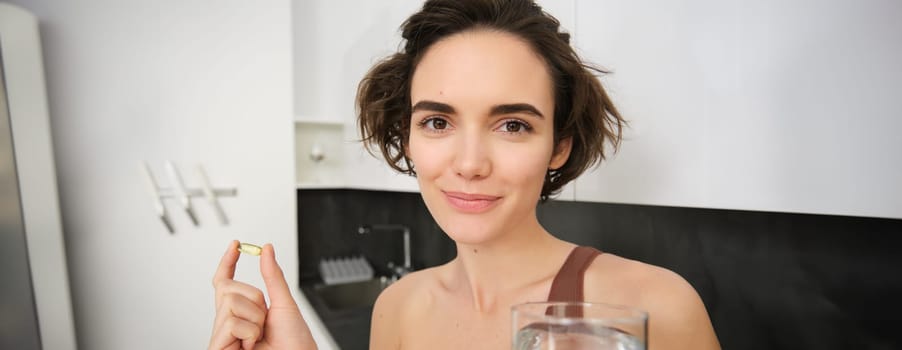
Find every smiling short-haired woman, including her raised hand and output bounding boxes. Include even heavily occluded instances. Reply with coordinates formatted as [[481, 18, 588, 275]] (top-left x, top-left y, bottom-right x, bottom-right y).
[[211, 0, 719, 349]]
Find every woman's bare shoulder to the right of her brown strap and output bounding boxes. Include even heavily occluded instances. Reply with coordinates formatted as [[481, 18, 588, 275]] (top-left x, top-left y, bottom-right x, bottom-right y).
[[585, 254, 720, 350]]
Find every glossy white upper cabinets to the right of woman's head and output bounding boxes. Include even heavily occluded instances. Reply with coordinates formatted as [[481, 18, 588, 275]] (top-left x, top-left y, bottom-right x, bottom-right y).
[[576, 0, 902, 218]]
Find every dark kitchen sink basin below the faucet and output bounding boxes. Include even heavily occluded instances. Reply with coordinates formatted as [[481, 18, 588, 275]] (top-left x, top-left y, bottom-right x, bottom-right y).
[[313, 277, 391, 312]]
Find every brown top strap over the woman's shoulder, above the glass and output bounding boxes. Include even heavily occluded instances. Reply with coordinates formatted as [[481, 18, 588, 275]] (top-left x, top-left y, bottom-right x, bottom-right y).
[[548, 246, 601, 302]]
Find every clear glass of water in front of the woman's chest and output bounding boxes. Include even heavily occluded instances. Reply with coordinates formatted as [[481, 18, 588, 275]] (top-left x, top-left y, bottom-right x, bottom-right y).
[[511, 302, 648, 350]]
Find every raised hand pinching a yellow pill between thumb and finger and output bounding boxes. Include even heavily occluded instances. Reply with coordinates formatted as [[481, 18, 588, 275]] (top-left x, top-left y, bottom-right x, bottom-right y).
[[209, 241, 316, 350]]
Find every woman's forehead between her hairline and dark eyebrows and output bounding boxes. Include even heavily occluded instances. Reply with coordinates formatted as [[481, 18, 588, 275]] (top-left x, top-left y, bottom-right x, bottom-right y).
[[411, 30, 554, 112]]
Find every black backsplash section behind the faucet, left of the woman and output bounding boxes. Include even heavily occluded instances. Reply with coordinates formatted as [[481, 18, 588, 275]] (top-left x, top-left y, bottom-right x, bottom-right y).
[[298, 190, 457, 283]]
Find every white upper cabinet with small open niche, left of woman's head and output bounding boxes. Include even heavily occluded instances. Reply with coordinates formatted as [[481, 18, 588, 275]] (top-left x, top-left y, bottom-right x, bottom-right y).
[[292, 0, 422, 192]]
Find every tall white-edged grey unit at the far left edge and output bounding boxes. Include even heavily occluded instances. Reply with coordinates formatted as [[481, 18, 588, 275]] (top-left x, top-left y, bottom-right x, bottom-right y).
[[0, 2, 76, 350]]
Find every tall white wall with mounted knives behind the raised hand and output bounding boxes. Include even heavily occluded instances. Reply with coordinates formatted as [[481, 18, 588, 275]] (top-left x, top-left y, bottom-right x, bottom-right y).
[[4, 0, 330, 350]]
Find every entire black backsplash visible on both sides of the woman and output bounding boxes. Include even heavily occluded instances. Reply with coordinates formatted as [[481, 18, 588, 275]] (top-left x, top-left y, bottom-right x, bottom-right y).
[[298, 189, 902, 349]]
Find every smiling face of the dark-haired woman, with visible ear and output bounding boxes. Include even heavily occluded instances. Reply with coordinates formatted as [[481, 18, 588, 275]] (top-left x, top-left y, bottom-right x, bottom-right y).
[[407, 31, 569, 244]]
